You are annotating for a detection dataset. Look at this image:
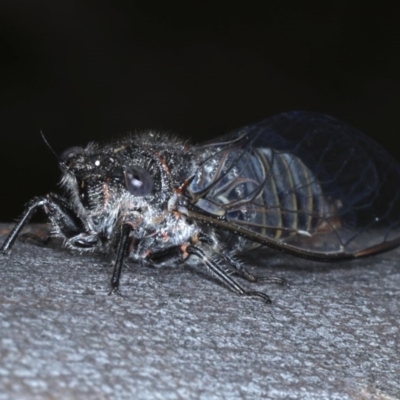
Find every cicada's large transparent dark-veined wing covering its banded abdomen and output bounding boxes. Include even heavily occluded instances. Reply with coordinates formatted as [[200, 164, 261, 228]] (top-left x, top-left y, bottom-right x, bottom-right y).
[[184, 112, 400, 259]]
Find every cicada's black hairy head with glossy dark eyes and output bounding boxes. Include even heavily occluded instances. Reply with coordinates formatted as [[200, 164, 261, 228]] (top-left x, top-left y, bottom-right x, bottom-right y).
[[60, 141, 160, 232]]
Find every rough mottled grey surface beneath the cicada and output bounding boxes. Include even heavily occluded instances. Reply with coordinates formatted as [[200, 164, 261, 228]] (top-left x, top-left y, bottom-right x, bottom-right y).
[[0, 225, 400, 400]]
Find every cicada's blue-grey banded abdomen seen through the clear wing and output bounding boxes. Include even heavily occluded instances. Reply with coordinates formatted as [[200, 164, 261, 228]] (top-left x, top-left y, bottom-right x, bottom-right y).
[[190, 148, 331, 240]]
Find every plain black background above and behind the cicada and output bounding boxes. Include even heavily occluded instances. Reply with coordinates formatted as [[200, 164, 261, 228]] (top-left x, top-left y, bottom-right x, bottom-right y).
[[0, 0, 400, 221]]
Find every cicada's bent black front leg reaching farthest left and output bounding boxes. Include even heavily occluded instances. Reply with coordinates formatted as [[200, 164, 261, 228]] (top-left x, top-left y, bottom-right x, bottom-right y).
[[0, 193, 84, 254]]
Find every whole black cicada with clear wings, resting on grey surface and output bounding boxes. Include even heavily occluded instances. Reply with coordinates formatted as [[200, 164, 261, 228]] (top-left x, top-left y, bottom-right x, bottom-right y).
[[2, 112, 400, 302]]
